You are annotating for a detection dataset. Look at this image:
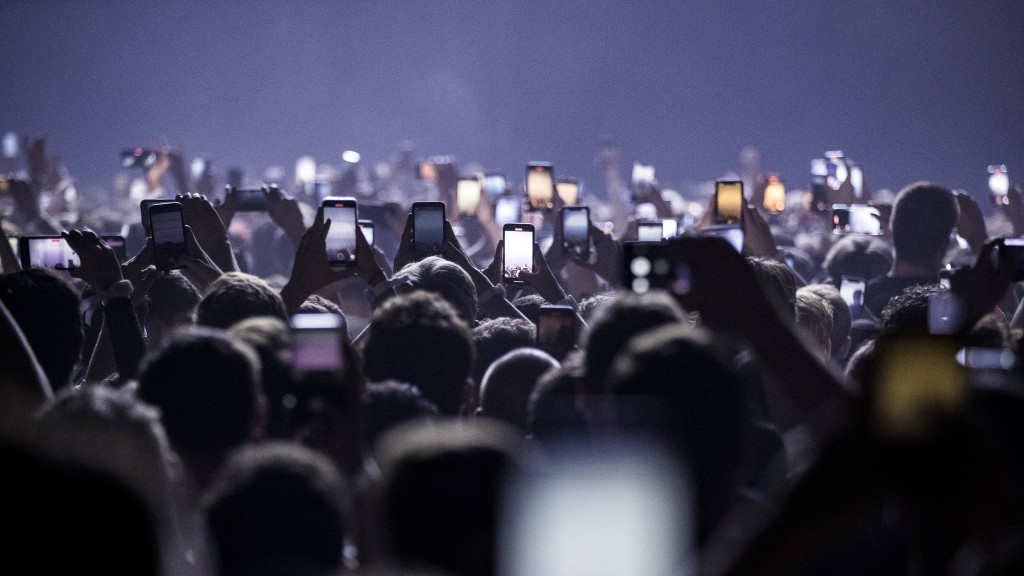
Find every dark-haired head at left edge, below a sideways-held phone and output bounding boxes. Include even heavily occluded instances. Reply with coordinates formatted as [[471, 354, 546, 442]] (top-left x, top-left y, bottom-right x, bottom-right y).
[[0, 269, 85, 393]]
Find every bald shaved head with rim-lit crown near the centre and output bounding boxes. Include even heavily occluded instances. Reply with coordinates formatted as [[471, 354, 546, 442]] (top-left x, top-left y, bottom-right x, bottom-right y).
[[479, 347, 559, 434]]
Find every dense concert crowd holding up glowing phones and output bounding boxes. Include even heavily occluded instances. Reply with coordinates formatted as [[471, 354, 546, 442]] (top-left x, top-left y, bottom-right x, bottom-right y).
[[0, 138, 1024, 576]]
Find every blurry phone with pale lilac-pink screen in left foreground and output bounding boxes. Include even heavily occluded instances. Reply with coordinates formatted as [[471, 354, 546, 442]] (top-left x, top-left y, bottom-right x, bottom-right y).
[[291, 313, 348, 374]]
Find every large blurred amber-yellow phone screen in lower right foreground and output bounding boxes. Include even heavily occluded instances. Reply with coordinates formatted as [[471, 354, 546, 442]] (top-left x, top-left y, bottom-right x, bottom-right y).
[[865, 335, 968, 442]]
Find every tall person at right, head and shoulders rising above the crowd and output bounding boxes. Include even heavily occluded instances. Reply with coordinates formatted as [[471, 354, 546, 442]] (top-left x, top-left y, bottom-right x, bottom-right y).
[[864, 181, 961, 317]]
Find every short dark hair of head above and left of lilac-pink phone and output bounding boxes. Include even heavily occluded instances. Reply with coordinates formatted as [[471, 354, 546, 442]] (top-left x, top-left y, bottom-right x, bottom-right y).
[[196, 272, 289, 328]]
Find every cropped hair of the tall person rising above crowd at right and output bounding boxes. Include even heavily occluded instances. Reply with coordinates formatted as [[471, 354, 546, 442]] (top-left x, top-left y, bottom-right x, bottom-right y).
[[890, 181, 959, 262]]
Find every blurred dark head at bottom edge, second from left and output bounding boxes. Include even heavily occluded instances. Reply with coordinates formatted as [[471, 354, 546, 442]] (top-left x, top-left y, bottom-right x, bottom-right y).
[[202, 441, 346, 576]]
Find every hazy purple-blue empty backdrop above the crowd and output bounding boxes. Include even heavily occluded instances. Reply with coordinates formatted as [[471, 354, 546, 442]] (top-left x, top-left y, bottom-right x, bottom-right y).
[[0, 0, 1024, 201]]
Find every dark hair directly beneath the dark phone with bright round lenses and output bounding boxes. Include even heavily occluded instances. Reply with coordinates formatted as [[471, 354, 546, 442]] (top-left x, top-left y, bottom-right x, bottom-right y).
[[580, 290, 686, 394]]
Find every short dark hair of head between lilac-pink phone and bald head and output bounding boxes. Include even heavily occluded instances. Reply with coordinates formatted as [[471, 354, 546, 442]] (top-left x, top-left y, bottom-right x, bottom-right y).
[[361, 290, 474, 415]]
